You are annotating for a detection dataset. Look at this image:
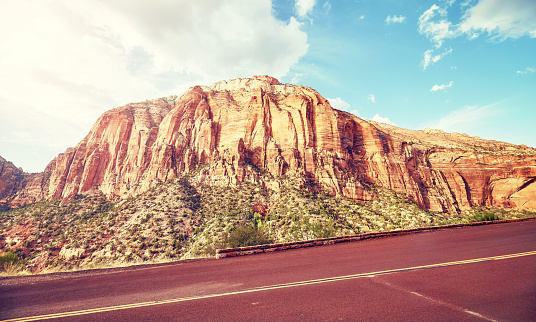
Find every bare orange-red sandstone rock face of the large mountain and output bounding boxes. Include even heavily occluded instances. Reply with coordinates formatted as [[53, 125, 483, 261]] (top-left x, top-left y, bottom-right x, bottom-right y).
[[0, 76, 536, 212]]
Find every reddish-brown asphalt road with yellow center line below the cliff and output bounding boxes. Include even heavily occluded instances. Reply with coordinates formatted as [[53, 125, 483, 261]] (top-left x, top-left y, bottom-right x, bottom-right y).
[[0, 221, 536, 321]]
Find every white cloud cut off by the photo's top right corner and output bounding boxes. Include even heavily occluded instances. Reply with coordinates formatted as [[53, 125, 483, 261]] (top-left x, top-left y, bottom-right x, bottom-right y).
[[459, 0, 536, 40]]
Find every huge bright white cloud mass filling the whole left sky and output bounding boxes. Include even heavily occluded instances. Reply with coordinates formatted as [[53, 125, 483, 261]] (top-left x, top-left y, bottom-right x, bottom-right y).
[[0, 0, 310, 171]]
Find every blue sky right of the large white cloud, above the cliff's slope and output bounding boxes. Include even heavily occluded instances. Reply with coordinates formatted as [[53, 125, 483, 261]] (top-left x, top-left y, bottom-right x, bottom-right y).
[[274, 1, 536, 146]]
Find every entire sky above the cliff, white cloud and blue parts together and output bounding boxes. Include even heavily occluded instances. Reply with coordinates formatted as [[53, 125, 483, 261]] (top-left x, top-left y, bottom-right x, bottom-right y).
[[0, 0, 536, 172]]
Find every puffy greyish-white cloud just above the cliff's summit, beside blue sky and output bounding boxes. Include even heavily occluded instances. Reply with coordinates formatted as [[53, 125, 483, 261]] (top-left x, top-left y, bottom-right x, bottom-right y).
[[68, 0, 307, 81]]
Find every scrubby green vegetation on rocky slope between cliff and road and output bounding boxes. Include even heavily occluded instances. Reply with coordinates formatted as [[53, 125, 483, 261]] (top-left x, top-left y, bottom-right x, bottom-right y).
[[0, 167, 535, 275]]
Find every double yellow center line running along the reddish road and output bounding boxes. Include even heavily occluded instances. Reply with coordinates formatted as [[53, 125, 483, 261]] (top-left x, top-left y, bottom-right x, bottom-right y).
[[4, 251, 536, 322]]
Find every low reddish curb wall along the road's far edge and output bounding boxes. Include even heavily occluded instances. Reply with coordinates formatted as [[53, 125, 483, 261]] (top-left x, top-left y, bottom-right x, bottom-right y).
[[216, 217, 536, 258]]
